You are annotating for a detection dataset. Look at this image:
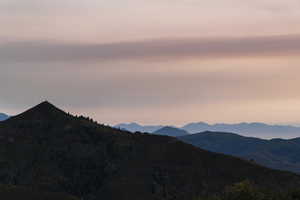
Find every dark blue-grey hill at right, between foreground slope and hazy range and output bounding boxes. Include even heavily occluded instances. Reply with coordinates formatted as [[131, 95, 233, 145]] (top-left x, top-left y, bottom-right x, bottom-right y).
[[180, 131, 300, 174]]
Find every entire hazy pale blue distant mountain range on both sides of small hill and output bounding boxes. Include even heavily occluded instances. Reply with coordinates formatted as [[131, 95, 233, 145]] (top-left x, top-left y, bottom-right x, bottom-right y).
[[115, 122, 300, 139]]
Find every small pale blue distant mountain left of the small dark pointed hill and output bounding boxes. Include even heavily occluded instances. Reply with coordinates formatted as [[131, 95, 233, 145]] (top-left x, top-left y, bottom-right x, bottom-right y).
[[114, 123, 163, 133]]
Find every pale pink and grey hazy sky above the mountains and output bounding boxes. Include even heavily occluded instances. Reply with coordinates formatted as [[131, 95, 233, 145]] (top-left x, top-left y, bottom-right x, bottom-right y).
[[0, 0, 300, 125]]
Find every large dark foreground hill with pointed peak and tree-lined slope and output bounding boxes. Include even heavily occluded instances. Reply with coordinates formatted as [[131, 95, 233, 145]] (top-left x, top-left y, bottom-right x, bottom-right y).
[[0, 102, 300, 200]]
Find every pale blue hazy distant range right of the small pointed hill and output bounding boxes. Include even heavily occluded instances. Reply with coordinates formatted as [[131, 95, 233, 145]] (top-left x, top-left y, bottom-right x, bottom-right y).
[[182, 122, 300, 138]]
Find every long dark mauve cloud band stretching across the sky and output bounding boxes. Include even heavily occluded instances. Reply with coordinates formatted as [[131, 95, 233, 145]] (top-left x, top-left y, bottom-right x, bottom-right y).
[[0, 35, 300, 63]]
